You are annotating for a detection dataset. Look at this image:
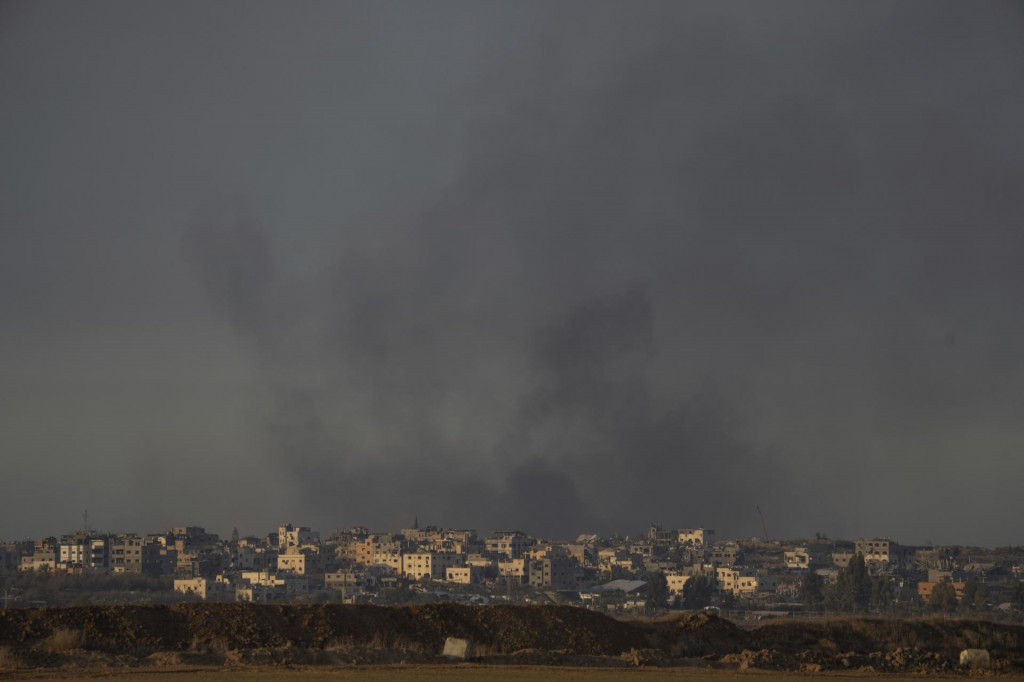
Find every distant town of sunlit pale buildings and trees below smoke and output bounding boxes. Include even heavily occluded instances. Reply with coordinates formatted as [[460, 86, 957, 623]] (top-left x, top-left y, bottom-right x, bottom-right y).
[[0, 522, 1024, 620]]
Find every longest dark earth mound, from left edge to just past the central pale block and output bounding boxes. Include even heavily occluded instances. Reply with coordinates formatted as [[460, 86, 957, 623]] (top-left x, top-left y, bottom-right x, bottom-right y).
[[0, 603, 644, 655]]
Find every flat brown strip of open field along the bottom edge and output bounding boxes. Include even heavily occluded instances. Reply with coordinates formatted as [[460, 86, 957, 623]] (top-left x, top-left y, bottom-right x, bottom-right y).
[[5, 665, 1024, 682]]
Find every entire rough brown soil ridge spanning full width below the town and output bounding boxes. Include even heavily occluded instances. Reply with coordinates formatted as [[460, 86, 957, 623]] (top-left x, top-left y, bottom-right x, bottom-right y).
[[0, 603, 1024, 673]]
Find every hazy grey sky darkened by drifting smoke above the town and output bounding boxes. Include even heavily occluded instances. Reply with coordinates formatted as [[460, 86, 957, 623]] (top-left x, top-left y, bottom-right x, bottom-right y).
[[0, 0, 1024, 546]]
